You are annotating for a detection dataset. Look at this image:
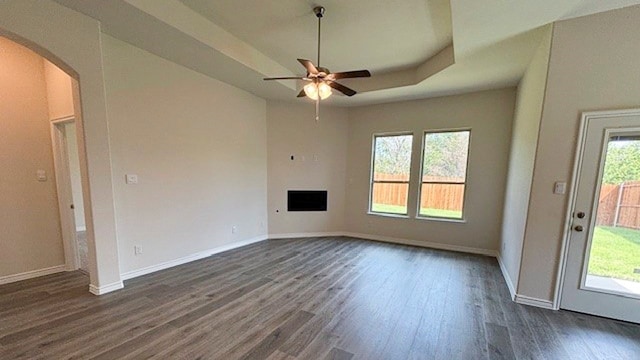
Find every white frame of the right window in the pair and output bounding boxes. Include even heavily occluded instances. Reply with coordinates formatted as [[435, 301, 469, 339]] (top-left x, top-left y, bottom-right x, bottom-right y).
[[416, 128, 472, 223]]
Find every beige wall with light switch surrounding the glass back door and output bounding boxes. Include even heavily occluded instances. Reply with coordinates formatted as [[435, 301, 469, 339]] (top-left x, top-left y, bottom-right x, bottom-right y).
[[518, 6, 640, 301]]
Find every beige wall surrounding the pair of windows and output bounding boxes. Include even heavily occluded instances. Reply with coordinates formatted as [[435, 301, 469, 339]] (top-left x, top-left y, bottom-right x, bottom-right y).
[[346, 88, 516, 252]]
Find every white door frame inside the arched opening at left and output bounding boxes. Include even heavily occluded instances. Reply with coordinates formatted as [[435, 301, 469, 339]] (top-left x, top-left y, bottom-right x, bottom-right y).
[[49, 116, 80, 271]]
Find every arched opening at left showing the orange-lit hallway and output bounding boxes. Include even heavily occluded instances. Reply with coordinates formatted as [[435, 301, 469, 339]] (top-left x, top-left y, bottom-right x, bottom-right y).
[[0, 36, 95, 284]]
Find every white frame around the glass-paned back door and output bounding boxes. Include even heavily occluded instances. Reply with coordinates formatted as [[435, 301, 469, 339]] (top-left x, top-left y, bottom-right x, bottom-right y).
[[553, 108, 640, 310]]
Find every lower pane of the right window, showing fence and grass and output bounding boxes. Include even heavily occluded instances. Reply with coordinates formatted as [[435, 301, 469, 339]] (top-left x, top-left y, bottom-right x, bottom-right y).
[[420, 184, 464, 219]]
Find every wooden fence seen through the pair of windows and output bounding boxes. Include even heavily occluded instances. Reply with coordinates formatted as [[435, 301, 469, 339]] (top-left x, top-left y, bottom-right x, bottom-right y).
[[373, 173, 464, 211]]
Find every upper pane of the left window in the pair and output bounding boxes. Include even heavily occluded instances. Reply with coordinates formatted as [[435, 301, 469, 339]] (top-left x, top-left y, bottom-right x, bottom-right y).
[[373, 135, 413, 181]]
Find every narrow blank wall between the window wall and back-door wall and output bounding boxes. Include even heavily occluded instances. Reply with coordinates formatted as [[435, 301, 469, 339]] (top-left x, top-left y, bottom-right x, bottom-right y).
[[500, 26, 553, 291]]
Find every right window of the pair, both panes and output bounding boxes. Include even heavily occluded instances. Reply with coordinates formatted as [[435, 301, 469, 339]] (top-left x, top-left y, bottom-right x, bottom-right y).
[[418, 130, 471, 220]]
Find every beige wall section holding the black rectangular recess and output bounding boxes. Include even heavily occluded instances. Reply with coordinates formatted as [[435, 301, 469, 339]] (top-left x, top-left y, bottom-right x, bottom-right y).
[[267, 99, 349, 237]]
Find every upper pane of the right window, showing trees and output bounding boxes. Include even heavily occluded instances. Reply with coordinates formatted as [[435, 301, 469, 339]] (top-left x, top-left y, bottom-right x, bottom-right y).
[[422, 131, 469, 182]]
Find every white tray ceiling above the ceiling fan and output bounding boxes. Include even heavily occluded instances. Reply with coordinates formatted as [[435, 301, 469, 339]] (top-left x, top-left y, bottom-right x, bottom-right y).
[[55, 0, 640, 106]]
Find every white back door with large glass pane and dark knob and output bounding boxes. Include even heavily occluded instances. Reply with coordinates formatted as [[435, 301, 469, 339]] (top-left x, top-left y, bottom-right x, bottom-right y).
[[560, 111, 640, 323]]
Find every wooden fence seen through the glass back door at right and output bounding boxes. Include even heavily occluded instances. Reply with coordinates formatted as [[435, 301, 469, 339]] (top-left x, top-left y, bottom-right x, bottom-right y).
[[596, 181, 640, 229]]
